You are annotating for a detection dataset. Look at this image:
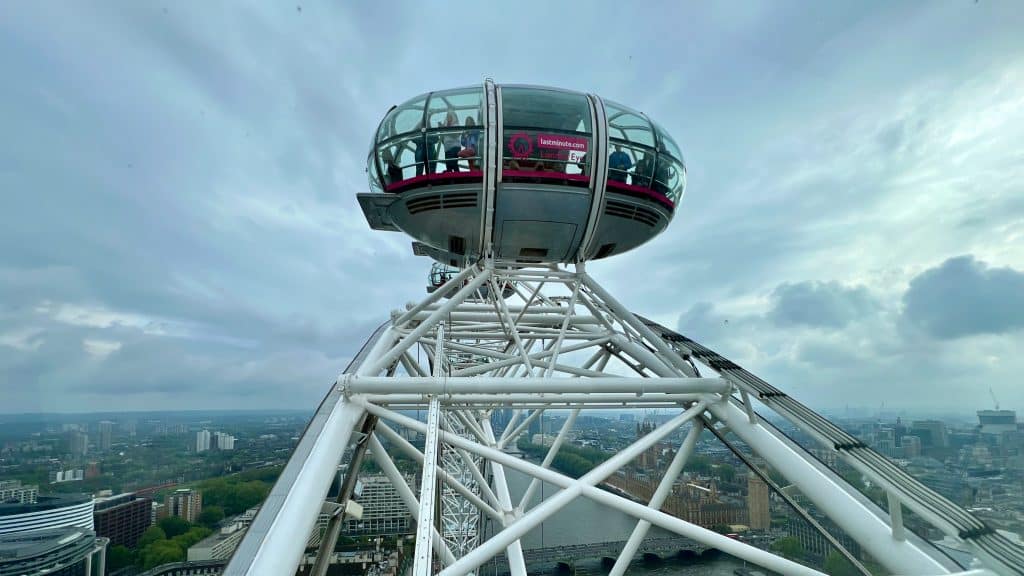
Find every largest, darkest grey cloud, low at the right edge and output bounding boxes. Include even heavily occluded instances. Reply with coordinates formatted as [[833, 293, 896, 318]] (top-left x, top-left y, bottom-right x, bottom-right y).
[[903, 255, 1024, 339]]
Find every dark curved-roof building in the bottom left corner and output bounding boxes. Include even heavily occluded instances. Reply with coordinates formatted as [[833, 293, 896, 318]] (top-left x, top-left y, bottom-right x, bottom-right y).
[[0, 527, 108, 576]]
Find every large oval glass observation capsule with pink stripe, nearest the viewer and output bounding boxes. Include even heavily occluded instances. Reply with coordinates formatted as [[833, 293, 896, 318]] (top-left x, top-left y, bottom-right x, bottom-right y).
[[358, 80, 686, 266]]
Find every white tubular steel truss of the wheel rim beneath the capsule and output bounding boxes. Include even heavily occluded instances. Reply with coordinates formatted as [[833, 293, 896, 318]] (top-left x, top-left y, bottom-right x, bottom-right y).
[[225, 261, 1024, 576]]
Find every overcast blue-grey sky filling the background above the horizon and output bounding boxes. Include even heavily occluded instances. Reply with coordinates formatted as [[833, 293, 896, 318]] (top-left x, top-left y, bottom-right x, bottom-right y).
[[0, 0, 1024, 412]]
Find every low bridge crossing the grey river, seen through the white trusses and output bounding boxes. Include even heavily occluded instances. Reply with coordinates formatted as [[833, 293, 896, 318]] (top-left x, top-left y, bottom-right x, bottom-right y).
[[480, 537, 710, 574]]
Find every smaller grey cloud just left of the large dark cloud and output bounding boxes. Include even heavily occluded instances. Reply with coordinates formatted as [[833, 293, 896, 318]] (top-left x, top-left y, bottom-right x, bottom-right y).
[[768, 282, 878, 328]]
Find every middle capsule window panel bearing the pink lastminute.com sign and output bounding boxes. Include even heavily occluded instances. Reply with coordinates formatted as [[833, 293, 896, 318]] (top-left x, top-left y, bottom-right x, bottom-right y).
[[501, 86, 594, 187]]
